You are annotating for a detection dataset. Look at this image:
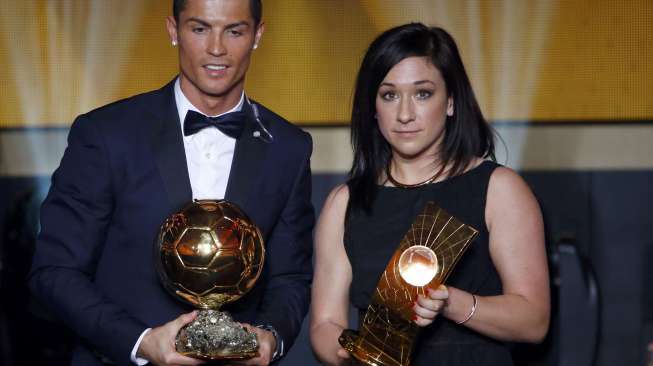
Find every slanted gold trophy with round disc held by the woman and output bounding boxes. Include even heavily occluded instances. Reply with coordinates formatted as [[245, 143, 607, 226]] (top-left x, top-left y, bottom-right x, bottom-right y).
[[339, 202, 478, 366]]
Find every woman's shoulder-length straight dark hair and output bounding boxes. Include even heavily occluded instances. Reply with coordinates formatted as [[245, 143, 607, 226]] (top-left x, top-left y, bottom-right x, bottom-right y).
[[347, 23, 495, 210]]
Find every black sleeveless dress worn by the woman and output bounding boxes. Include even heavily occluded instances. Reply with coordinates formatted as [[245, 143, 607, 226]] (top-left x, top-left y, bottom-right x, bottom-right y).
[[344, 161, 512, 366]]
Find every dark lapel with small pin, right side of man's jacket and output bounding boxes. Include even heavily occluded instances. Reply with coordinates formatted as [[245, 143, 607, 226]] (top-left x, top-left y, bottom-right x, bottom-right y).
[[225, 101, 269, 209]]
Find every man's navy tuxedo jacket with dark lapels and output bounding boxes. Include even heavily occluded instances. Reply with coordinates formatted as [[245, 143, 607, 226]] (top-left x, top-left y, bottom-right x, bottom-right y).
[[30, 78, 314, 365]]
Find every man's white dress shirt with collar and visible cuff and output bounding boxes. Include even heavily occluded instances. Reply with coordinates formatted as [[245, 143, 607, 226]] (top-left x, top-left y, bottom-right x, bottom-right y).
[[131, 78, 245, 366]]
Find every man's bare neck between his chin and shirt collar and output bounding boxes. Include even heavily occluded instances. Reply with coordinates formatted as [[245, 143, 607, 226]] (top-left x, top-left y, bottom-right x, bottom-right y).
[[179, 75, 243, 116]]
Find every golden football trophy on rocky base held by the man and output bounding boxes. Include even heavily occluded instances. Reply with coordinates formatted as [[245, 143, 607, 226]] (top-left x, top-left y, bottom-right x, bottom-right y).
[[154, 200, 265, 360]]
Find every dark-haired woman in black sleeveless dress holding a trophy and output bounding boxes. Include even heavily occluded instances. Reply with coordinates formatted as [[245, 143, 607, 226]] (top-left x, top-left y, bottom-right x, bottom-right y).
[[311, 23, 549, 365]]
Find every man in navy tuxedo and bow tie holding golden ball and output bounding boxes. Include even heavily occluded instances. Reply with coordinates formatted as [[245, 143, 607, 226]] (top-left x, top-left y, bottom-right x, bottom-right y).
[[30, 0, 314, 365]]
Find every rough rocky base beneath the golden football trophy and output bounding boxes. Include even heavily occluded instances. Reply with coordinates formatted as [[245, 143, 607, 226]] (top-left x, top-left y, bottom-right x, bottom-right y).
[[175, 310, 258, 360]]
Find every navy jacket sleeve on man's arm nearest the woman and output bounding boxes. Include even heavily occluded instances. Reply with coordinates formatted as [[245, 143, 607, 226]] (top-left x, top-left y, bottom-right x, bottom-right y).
[[256, 132, 315, 350]]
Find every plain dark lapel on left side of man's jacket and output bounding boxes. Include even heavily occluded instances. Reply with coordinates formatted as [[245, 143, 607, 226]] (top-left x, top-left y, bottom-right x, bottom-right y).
[[151, 80, 193, 212]]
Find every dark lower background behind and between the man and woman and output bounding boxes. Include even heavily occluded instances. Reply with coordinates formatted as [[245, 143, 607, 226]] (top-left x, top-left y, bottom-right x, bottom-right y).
[[0, 170, 653, 366]]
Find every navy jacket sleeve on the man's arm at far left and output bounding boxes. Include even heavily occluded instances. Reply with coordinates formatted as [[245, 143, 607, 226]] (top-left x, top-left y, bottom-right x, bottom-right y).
[[29, 116, 146, 364]]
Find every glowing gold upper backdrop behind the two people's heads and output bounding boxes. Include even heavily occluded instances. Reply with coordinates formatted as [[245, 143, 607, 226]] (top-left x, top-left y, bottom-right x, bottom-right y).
[[0, 0, 653, 127]]
